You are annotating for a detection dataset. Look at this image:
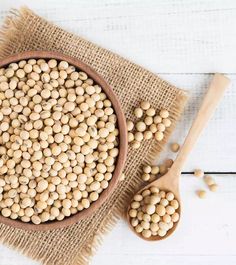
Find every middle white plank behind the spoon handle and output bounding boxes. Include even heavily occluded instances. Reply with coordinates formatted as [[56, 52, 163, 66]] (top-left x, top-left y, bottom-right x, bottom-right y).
[[157, 74, 236, 172]]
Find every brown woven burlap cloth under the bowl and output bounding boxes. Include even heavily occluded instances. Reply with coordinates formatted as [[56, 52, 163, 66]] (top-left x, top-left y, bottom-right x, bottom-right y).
[[0, 8, 186, 265]]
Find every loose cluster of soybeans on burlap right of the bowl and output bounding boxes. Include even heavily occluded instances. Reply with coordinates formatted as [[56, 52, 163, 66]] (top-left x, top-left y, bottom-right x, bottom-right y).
[[127, 101, 171, 149]]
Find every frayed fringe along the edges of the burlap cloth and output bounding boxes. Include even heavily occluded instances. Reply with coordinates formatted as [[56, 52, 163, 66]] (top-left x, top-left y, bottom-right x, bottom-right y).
[[0, 7, 187, 265]]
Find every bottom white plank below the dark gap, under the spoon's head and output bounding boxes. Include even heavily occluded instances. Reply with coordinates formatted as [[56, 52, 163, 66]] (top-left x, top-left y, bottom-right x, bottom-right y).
[[0, 175, 236, 265]]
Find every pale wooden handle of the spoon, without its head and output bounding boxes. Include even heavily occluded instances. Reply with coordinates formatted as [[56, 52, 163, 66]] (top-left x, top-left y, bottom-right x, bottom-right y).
[[170, 74, 230, 175]]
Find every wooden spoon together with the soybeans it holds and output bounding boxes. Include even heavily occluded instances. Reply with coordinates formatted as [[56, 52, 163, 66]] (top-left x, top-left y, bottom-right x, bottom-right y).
[[127, 74, 230, 241]]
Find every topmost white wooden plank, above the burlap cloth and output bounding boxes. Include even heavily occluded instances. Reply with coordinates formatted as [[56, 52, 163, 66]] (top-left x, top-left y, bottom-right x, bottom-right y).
[[0, 0, 236, 73]]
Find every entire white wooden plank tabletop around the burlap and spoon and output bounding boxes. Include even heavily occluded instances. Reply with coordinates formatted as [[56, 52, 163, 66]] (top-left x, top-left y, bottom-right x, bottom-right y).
[[0, 0, 236, 265]]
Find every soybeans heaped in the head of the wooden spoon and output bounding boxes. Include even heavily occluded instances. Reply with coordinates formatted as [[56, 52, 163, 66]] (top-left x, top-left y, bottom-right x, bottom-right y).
[[129, 186, 179, 238]]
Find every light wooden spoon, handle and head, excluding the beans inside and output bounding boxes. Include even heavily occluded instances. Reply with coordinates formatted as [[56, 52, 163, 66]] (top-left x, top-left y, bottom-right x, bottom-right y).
[[127, 74, 230, 241]]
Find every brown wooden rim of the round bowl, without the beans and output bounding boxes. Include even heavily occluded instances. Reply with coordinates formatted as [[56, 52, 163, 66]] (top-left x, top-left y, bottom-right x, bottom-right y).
[[0, 51, 128, 231]]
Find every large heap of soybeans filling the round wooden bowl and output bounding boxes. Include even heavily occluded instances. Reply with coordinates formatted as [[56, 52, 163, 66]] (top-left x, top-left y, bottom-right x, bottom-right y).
[[0, 59, 119, 224]]
